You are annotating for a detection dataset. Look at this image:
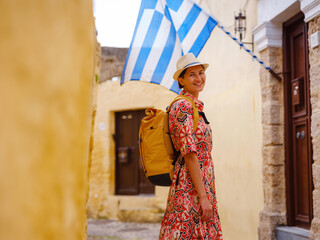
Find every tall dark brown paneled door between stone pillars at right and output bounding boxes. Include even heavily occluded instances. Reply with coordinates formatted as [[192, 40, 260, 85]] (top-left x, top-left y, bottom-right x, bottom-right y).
[[284, 13, 313, 228]]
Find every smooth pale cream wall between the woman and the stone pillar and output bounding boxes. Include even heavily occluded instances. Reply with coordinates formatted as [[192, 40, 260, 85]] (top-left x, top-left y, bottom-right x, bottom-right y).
[[199, 0, 263, 240]]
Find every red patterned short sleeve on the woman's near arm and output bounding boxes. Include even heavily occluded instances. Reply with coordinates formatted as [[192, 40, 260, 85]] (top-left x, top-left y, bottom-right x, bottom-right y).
[[169, 100, 196, 157]]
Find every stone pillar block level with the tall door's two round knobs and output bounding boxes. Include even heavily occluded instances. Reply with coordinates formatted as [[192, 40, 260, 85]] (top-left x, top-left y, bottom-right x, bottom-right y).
[[262, 125, 284, 146]]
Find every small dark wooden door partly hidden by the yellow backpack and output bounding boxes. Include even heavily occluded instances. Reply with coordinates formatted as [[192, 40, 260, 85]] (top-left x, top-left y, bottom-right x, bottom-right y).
[[115, 110, 154, 195]]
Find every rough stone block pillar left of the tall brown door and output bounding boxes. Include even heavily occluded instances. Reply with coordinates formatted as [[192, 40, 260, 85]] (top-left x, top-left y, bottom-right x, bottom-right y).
[[259, 47, 286, 240]]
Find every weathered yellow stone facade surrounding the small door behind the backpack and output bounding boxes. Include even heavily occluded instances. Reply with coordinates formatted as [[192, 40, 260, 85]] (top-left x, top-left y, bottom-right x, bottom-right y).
[[87, 47, 176, 222]]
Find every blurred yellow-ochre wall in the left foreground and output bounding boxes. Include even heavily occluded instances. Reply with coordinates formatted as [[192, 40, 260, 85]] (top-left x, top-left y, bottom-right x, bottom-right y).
[[0, 0, 95, 240]]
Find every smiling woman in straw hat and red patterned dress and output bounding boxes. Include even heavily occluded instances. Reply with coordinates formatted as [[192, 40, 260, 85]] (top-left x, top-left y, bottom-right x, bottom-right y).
[[159, 53, 222, 240]]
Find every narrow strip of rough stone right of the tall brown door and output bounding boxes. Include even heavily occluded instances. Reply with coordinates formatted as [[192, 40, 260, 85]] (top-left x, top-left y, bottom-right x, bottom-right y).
[[308, 16, 320, 240]]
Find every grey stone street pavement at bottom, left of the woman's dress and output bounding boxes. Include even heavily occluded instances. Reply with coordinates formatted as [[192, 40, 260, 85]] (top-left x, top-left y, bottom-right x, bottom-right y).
[[87, 219, 160, 240]]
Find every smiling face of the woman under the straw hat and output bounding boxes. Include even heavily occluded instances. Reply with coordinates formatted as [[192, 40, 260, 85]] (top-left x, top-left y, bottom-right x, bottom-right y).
[[178, 65, 206, 98]]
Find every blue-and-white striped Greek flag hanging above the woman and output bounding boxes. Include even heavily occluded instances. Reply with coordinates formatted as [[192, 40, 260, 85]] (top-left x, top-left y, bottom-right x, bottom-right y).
[[120, 0, 217, 93]]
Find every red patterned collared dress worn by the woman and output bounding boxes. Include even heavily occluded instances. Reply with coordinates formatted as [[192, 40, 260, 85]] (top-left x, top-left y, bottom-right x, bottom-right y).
[[159, 91, 223, 240]]
